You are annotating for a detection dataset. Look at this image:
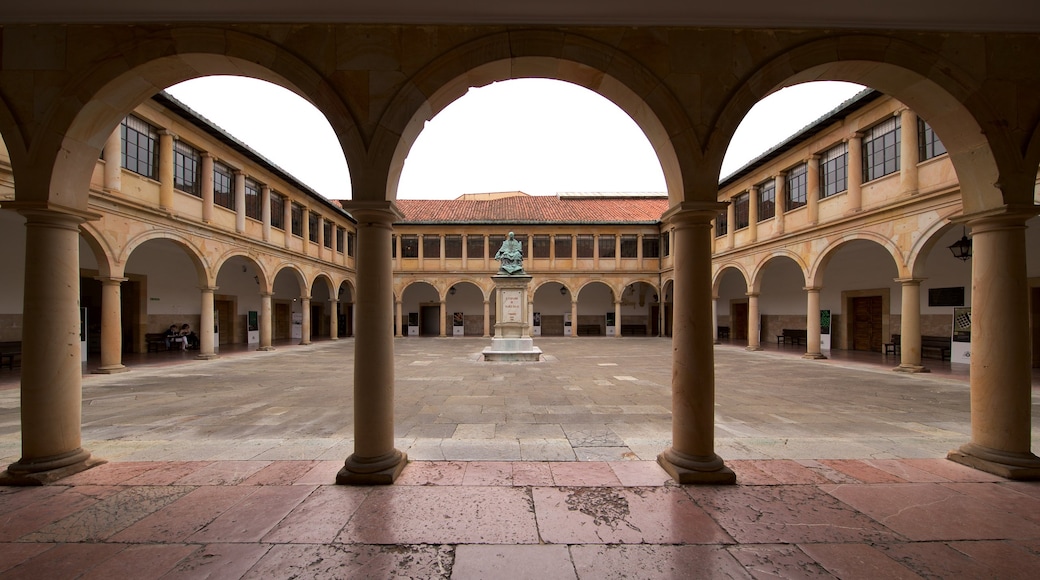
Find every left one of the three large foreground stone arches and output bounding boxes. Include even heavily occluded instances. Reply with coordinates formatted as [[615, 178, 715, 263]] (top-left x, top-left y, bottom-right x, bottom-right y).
[[31, 27, 365, 209]]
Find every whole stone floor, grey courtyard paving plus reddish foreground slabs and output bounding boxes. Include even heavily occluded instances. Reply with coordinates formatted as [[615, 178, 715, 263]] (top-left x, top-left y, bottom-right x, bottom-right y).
[[0, 338, 1040, 580]]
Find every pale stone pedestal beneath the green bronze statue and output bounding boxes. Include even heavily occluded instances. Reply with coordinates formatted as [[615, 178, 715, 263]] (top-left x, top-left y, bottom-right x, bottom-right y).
[[484, 274, 542, 362]]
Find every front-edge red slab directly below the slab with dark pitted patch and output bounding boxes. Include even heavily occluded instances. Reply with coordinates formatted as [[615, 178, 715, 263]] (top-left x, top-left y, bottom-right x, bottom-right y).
[[571, 546, 748, 580]]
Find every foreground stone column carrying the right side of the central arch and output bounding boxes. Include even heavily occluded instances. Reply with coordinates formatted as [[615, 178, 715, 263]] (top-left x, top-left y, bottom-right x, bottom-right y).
[[657, 202, 736, 483]]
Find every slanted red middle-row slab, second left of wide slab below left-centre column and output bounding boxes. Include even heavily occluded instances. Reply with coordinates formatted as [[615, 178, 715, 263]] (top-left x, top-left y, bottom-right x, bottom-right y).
[[188, 485, 314, 544]]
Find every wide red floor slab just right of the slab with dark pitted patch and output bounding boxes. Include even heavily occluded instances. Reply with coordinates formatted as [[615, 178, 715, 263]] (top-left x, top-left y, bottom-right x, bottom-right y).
[[685, 485, 898, 544]]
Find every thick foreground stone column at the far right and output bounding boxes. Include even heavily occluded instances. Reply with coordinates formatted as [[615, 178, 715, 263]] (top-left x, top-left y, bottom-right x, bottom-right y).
[[947, 208, 1040, 479]]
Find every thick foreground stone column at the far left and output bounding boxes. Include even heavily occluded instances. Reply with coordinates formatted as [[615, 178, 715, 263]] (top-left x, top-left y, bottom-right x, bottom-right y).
[[0, 208, 104, 484]]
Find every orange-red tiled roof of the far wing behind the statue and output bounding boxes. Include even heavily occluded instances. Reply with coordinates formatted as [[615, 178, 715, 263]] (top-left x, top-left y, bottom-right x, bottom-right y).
[[388, 195, 668, 223]]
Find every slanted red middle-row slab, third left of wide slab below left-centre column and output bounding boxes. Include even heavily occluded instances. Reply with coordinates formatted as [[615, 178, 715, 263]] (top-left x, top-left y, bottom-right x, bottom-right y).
[[111, 485, 257, 543]]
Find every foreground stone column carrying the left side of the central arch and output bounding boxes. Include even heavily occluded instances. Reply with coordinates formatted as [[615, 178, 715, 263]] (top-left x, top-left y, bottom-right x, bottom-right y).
[[336, 202, 408, 484]]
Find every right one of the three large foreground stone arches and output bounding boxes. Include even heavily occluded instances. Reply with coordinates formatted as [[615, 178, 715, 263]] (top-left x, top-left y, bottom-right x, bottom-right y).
[[708, 34, 1015, 213]]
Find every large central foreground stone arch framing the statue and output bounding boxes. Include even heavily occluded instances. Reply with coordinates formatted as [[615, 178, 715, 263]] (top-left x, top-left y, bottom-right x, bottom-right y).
[[371, 30, 694, 205]]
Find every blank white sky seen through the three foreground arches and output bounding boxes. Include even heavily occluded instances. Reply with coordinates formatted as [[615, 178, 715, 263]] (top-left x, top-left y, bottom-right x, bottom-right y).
[[166, 77, 862, 200]]
